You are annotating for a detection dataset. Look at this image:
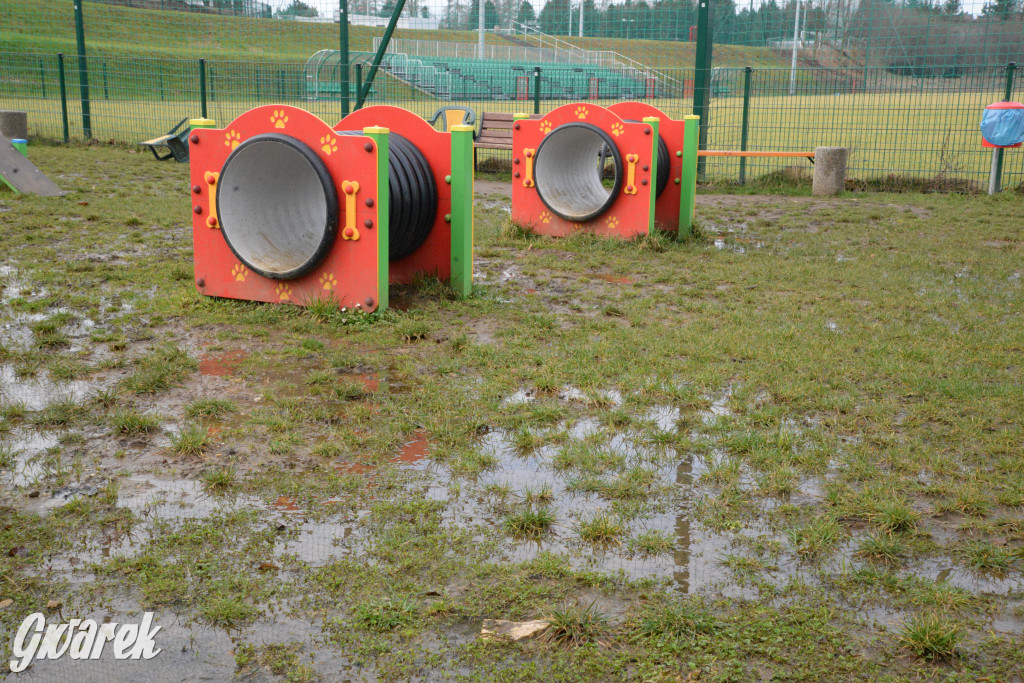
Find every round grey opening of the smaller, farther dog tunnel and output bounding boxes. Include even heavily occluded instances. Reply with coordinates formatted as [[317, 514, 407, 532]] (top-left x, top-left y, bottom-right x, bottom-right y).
[[534, 123, 623, 222]]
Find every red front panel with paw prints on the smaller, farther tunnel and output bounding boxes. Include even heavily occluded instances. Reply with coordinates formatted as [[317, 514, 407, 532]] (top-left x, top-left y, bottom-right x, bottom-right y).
[[512, 103, 655, 239]]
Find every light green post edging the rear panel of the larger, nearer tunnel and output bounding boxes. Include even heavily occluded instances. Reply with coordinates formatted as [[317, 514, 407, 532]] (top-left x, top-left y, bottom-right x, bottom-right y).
[[451, 125, 473, 299]]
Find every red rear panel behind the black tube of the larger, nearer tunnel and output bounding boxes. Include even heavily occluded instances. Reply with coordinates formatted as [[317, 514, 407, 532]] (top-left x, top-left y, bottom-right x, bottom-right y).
[[334, 104, 452, 285]]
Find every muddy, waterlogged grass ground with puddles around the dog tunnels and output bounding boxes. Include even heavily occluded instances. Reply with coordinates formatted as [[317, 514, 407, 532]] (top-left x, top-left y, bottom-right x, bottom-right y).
[[0, 144, 1024, 681]]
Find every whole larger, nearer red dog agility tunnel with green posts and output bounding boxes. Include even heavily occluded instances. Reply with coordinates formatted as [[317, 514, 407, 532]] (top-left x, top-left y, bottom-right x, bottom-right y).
[[190, 105, 473, 310]]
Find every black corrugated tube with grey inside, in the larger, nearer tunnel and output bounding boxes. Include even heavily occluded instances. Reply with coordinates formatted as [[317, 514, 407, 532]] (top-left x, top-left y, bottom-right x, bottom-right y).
[[217, 130, 437, 280]]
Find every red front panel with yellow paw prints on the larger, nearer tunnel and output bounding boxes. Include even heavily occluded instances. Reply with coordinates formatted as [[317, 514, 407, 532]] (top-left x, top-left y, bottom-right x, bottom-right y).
[[189, 104, 387, 310]]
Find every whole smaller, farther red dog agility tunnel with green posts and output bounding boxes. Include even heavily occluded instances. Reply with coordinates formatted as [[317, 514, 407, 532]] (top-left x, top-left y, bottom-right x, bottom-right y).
[[512, 102, 696, 238]]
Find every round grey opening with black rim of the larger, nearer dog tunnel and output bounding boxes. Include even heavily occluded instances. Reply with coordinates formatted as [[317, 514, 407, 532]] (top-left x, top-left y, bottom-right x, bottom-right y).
[[217, 133, 338, 280]]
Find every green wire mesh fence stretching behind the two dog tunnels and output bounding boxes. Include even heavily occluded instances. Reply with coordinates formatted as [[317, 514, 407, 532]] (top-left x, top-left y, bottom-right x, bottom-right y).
[[0, 0, 1024, 189]]
